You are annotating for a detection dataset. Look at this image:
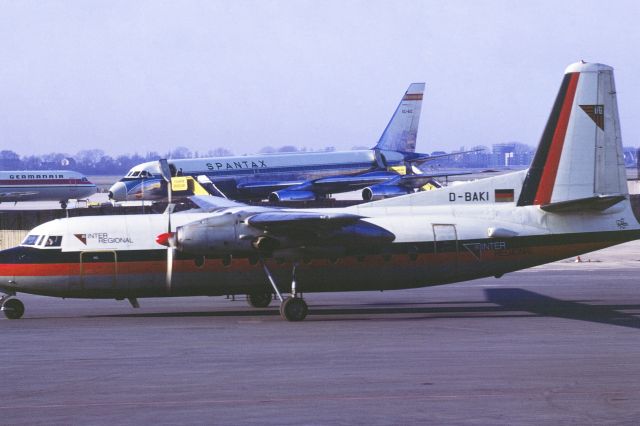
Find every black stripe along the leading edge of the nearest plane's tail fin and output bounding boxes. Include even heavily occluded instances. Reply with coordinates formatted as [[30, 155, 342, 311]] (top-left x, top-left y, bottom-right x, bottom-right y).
[[518, 74, 571, 206]]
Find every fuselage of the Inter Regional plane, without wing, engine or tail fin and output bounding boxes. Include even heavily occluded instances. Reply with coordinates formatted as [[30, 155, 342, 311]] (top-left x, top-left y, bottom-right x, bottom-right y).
[[0, 173, 640, 298]]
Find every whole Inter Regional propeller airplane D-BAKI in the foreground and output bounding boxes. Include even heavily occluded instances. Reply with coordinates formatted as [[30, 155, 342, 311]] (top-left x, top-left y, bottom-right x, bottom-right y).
[[0, 59, 640, 321]]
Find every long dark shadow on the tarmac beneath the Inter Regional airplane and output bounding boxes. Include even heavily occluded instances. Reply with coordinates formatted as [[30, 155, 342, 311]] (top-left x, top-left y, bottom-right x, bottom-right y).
[[89, 288, 640, 329]]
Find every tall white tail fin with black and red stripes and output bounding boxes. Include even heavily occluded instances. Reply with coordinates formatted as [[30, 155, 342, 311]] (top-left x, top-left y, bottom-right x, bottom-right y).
[[518, 62, 628, 206]]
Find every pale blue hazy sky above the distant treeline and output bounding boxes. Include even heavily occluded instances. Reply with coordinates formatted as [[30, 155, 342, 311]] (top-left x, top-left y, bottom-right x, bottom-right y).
[[0, 0, 640, 155]]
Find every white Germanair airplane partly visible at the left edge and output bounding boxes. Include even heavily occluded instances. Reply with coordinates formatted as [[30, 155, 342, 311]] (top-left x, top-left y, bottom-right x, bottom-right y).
[[0, 170, 96, 209]]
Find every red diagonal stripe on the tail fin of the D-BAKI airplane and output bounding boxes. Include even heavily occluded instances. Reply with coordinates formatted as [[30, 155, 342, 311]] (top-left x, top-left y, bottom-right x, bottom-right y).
[[533, 73, 580, 205]]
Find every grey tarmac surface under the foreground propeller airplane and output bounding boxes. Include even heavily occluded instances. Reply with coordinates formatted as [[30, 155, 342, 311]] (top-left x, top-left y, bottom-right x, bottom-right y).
[[0, 242, 640, 425]]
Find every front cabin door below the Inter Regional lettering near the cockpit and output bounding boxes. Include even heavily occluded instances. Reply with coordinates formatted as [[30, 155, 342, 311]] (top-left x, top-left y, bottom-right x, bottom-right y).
[[80, 250, 118, 292]]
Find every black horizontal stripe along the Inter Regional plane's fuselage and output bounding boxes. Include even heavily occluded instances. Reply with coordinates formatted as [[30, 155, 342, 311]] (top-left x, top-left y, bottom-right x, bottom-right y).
[[0, 230, 640, 264]]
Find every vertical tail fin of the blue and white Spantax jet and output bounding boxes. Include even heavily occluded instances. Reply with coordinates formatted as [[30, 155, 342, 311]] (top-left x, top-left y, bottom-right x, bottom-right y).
[[375, 83, 424, 152]]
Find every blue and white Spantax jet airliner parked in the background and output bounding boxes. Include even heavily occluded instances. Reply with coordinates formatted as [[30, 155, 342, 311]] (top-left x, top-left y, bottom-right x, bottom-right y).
[[109, 83, 460, 202]]
